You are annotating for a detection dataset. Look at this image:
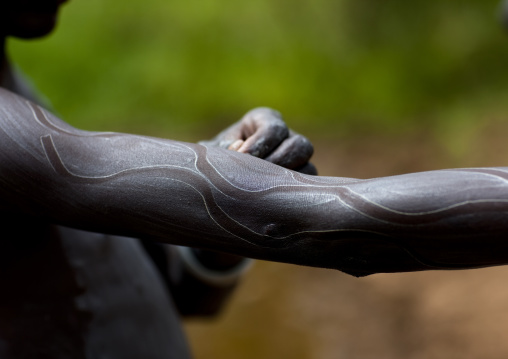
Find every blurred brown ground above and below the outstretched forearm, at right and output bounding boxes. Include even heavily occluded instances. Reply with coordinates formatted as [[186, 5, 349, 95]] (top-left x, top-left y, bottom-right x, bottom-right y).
[[186, 119, 508, 359]]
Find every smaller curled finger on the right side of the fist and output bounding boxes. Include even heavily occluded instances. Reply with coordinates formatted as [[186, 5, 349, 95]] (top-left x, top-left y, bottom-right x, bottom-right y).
[[265, 133, 314, 169]]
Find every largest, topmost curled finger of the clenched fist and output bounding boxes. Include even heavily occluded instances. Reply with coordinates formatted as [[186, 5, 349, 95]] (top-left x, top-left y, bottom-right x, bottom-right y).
[[238, 107, 289, 158]]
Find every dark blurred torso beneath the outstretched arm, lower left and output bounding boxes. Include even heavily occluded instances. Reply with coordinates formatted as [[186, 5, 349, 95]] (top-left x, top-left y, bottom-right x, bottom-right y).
[[0, 217, 190, 359]]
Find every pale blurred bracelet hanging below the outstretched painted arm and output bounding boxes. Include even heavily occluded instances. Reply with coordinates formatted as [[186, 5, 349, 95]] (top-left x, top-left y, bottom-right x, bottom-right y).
[[175, 246, 254, 287]]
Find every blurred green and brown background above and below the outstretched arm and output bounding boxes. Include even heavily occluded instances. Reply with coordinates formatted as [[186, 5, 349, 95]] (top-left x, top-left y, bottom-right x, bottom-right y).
[[8, 0, 508, 359]]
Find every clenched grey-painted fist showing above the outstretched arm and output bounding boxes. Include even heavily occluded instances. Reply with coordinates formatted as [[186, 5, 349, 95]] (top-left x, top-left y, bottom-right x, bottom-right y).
[[203, 107, 317, 175]]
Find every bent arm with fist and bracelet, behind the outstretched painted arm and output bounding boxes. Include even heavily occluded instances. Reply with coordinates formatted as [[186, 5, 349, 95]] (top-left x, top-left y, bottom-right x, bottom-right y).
[[142, 107, 316, 316]]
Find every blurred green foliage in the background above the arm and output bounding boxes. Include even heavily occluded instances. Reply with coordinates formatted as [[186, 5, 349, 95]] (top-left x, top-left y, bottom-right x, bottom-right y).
[[6, 0, 508, 139]]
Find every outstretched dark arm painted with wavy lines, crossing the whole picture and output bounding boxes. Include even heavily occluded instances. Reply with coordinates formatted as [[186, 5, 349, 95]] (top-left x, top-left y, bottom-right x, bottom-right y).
[[0, 91, 508, 275]]
